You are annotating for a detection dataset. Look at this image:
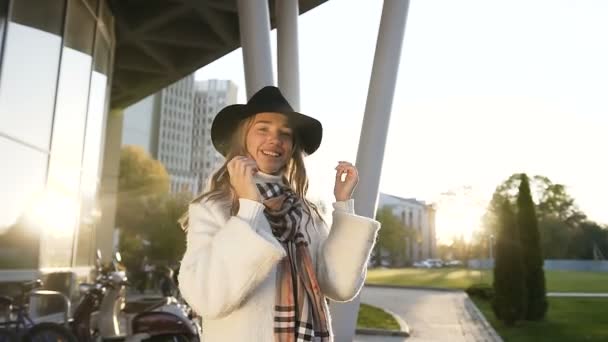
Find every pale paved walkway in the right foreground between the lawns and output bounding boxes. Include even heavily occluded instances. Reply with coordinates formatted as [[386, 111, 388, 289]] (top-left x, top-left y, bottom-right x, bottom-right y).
[[355, 287, 502, 342]]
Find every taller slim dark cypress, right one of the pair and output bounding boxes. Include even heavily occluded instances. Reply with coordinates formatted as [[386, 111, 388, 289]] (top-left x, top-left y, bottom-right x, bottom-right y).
[[517, 174, 548, 321]]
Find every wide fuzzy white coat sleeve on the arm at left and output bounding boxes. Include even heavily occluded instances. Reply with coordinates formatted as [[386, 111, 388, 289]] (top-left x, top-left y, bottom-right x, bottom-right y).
[[179, 199, 285, 319]]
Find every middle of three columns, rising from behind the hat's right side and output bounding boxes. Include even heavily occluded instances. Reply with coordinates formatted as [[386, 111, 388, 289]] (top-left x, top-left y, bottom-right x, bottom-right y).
[[275, 0, 300, 111]]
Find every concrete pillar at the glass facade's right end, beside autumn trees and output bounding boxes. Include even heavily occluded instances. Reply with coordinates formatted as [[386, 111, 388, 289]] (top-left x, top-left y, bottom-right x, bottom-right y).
[[95, 110, 123, 262]]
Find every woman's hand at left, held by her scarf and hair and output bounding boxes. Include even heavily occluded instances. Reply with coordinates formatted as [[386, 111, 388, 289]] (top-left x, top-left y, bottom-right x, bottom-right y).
[[227, 156, 261, 202]]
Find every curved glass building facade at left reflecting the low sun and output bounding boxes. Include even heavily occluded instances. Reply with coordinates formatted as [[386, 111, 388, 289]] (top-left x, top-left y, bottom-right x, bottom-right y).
[[0, 0, 115, 280]]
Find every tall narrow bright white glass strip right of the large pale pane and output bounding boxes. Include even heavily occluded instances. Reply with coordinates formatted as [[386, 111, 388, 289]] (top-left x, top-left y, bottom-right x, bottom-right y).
[[40, 48, 92, 267]]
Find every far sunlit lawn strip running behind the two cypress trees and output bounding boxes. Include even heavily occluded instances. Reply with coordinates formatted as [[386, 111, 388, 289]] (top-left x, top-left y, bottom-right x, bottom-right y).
[[366, 268, 608, 292]]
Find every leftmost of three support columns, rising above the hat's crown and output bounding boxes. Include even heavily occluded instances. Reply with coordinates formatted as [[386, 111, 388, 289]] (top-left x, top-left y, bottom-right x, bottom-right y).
[[237, 0, 274, 98]]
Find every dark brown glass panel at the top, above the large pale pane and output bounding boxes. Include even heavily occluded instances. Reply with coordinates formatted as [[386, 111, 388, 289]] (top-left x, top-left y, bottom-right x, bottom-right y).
[[11, 0, 65, 36]]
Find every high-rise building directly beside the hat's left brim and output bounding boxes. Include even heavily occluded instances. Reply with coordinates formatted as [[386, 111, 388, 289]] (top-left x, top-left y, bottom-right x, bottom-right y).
[[192, 80, 237, 193]]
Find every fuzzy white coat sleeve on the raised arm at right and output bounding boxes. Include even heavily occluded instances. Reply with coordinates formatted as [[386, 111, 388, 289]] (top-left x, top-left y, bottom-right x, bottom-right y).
[[317, 199, 380, 302]]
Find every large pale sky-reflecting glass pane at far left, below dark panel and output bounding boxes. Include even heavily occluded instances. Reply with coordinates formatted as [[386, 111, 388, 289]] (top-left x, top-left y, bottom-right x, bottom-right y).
[[0, 22, 61, 150]]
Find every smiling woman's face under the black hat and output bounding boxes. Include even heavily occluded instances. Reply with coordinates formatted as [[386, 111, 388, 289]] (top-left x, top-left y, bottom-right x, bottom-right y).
[[246, 113, 293, 174]]
